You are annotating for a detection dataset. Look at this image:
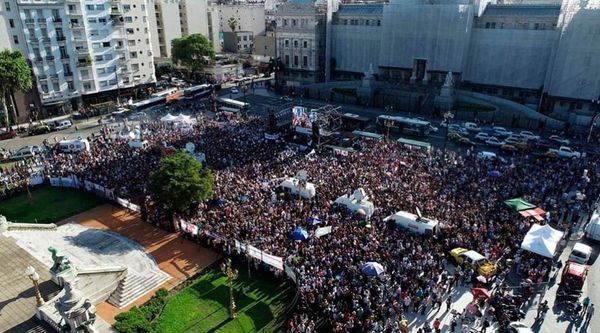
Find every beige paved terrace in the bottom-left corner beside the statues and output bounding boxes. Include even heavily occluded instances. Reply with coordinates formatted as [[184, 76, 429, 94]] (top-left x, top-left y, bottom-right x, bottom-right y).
[[0, 235, 59, 332]]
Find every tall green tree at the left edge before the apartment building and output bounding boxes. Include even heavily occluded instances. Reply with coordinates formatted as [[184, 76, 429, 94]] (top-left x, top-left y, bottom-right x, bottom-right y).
[[0, 50, 32, 130]]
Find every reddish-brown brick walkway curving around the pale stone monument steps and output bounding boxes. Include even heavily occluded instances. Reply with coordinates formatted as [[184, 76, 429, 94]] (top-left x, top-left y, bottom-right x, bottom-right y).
[[65, 205, 220, 323]]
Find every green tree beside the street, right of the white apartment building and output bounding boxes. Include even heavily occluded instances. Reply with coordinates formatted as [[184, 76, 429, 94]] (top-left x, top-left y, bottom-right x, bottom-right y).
[[171, 34, 215, 74]]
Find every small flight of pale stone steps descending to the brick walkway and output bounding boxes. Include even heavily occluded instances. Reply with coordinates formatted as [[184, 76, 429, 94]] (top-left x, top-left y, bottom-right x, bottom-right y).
[[108, 271, 170, 308]]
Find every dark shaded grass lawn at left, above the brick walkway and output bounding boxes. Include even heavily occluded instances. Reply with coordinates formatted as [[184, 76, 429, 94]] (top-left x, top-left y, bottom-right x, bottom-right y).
[[0, 185, 104, 223]]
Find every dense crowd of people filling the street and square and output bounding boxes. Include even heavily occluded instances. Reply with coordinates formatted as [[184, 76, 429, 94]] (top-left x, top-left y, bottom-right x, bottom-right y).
[[1, 113, 599, 332]]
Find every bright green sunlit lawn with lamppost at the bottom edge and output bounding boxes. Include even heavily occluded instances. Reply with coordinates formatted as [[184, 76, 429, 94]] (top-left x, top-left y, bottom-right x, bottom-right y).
[[156, 269, 293, 333]]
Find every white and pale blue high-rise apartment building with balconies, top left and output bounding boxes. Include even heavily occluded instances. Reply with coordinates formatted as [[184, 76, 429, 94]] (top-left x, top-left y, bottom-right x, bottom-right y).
[[0, 0, 156, 113]]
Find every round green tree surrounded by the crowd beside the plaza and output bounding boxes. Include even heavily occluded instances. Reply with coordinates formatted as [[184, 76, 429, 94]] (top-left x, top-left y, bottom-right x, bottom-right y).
[[150, 150, 214, 213]]
